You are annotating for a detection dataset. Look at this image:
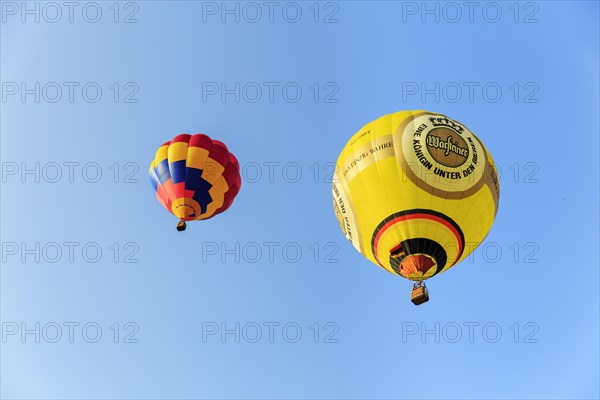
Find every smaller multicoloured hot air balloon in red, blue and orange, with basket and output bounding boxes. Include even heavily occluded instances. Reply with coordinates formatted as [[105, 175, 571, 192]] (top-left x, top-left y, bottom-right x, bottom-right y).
[[149, 134, 242, 231]]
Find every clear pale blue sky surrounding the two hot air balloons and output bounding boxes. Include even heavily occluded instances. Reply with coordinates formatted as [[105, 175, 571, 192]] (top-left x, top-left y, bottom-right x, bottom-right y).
[[0, 1, 600, 399]]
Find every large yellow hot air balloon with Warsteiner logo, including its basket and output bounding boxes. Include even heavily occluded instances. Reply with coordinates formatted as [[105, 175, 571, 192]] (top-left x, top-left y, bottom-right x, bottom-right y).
[[332, 111, 500, 305]]
